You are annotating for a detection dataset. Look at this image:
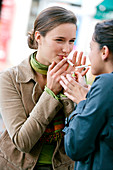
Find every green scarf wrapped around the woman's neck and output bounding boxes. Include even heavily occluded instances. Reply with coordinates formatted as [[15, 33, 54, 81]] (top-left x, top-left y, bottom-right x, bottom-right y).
[[30, 52, 49, 75]]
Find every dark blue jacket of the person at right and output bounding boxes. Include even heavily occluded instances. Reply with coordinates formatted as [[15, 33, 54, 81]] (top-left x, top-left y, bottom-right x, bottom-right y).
[[64, 73, 113, 170]]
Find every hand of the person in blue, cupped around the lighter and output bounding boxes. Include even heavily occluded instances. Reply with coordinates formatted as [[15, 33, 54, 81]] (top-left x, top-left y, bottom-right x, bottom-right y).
[[60, 73, 89, 104]]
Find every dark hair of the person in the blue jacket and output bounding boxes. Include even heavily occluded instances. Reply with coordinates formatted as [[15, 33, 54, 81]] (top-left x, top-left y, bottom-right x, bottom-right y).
[[93, 19, 113, 53]]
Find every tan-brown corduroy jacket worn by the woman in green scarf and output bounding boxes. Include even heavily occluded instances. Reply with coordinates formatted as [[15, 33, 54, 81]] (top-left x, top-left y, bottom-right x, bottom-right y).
[[0, 58, 74, 170]]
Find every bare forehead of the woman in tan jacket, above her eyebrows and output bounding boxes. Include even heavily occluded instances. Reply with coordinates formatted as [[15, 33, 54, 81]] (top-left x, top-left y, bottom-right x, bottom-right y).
[[46, 23, 76, 38]]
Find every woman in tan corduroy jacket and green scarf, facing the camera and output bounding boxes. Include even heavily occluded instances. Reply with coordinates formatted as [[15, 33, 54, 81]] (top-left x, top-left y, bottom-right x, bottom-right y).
[[0, 6, 85, 170]]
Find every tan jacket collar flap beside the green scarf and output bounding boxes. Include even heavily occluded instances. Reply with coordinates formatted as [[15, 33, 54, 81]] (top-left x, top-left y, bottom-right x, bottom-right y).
[[16, 56, 35, 83]]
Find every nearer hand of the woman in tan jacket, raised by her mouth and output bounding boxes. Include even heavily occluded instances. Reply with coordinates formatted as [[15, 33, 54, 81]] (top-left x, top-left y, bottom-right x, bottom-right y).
[[47, 59, 69, 95]]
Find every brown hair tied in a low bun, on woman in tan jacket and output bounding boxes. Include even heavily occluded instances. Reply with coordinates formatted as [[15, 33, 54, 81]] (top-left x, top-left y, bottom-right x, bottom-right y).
[[28, 6, 77, 49]]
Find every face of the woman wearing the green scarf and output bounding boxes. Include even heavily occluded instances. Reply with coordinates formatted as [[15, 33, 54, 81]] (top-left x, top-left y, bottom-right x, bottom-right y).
[[35, 23, 76, 65]]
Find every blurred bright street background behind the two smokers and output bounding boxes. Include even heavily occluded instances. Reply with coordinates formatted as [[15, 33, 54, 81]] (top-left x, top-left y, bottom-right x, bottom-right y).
[[0, 0, 113, 134]]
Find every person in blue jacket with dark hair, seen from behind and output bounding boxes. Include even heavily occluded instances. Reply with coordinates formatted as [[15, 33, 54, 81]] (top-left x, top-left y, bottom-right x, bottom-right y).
[[60, 20, 113, 170]]
